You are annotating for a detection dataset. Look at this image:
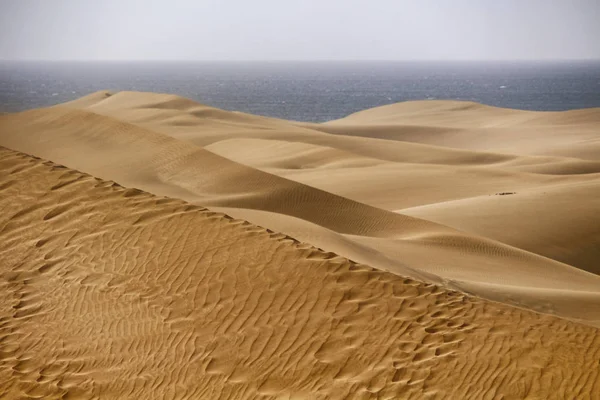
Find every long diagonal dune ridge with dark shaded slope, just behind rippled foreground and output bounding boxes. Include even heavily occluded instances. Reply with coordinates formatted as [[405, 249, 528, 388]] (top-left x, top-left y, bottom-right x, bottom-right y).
[[0, 104, 460, 241]]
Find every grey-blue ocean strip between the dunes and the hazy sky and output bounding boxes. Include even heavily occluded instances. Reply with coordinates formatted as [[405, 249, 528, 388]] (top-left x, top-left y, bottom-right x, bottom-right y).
[[0, 61, 600, 122]]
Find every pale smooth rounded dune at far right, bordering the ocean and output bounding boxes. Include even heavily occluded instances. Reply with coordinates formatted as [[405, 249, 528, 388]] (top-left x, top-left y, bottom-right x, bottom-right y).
[[322, 101, 600, 161]]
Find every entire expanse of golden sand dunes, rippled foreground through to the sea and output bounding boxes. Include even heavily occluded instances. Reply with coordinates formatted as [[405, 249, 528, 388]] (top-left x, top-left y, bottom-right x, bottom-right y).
[[0, 92, 600, 399]]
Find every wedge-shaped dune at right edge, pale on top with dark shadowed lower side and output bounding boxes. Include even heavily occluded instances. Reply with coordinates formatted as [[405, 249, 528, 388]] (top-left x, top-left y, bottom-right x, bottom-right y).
[[399, 179, 600, 274]]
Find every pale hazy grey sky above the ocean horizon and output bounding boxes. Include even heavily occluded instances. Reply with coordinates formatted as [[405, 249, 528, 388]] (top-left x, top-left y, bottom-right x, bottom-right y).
[[0, 0, 600, 60]]
